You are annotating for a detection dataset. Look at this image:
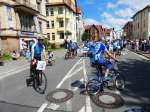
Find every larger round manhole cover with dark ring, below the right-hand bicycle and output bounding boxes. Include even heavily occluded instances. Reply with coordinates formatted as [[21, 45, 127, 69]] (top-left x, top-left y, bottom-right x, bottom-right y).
[[91, 92, 124, 108]]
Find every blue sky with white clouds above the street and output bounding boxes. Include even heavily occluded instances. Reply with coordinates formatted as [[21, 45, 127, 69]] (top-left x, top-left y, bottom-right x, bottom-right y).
[[77, 0, 150, 29]]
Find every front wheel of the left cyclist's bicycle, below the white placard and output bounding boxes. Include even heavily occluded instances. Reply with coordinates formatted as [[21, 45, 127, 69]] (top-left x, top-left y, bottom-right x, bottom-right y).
[[33, 71, 47, 94]]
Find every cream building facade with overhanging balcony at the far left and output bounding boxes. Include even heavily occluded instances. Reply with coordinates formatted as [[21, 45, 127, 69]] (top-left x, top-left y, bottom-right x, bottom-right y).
[[0, 0, 46, 51]]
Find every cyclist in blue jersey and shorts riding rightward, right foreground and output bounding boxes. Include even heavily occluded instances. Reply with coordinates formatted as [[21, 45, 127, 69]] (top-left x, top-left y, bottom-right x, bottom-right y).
[[94, 39, 118, 78]]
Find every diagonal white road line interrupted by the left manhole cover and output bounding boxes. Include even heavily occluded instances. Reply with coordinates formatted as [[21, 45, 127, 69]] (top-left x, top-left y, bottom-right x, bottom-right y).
[[37, 58, 82, 112]]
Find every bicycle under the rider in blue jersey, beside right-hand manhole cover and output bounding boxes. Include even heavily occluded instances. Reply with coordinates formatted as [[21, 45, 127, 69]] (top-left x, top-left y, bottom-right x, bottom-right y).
[[86, 60, 125, 94]]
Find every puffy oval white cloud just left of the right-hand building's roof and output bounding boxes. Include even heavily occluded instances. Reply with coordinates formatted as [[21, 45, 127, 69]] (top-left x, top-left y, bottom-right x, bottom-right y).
[[115, 8, 135, 17]]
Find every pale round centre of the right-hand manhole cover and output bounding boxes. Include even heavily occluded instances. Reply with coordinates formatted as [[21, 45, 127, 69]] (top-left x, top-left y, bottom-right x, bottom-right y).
[[99, 95, 115, 104]]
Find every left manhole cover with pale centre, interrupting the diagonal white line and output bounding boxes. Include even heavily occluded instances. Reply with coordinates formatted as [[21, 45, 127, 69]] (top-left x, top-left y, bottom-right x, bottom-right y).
[[46, 89, 73, 103]]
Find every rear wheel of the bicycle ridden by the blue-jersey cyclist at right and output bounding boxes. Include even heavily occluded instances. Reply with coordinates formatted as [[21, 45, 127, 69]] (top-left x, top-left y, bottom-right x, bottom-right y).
[[86, 79, 103, 95]]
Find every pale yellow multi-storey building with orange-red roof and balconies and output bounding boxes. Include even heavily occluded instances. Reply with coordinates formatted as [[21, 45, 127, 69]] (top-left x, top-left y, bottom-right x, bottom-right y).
[[46, 0, 77, 45]]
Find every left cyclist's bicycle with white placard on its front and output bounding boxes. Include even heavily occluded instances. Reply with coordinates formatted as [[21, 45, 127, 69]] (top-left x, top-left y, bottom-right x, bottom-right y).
[[26, 60, 47, 94]]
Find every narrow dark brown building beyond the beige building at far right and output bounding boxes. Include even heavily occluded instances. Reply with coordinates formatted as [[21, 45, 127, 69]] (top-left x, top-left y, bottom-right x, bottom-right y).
[[123, 21, 133, 40]]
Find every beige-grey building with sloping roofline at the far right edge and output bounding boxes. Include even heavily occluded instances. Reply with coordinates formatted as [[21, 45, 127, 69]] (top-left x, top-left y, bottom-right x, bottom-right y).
[[132, 5, 150, 39]]
